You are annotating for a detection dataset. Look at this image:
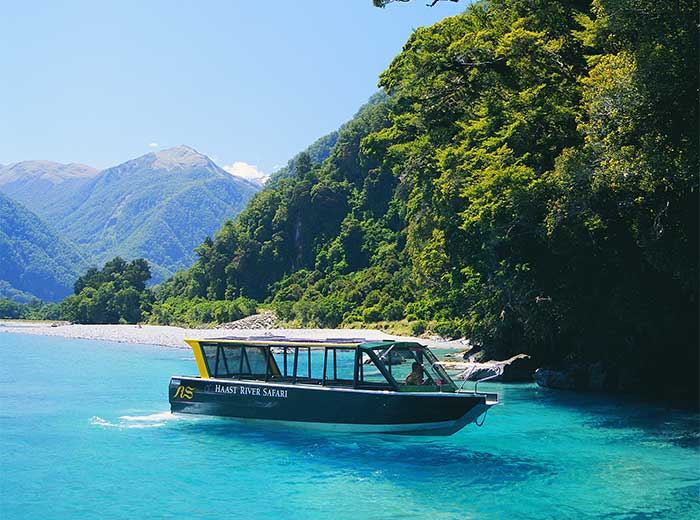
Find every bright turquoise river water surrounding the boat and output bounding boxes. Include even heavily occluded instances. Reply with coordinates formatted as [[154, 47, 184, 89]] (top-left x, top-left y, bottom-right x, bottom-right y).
[[0, 334, 700, 520]]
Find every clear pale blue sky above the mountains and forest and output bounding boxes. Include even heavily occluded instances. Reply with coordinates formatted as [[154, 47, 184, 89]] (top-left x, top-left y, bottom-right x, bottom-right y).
[[0, 0, 466, 177]]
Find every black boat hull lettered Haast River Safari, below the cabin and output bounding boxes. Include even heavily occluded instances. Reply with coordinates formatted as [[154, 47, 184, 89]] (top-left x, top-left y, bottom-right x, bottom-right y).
[[169, 377, 494, 435]]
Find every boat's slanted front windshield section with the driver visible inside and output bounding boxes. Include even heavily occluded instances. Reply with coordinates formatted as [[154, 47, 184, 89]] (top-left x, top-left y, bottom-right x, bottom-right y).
[[364, 343, 456, 392]]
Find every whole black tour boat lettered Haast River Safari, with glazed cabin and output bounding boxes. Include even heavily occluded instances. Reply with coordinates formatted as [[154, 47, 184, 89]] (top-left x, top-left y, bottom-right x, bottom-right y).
[[169, 336, 498, 435]]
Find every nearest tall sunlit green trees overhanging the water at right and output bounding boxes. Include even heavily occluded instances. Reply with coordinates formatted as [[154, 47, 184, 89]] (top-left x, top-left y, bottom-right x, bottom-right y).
[[365, 0, 698, 386]]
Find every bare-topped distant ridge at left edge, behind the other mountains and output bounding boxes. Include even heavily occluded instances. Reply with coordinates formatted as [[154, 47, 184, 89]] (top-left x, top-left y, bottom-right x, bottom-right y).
[[0, 161, 99, 215]]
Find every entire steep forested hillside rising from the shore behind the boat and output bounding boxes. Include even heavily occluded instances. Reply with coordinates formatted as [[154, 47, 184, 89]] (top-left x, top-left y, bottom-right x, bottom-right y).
[[162, 0, 698, 387]]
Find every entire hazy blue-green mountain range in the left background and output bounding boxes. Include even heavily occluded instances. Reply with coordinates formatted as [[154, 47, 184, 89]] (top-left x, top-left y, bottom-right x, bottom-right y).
[[0, 145, 259, 300]]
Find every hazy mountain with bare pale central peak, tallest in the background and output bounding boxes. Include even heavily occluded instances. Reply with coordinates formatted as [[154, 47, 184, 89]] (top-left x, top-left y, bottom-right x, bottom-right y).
[[49, 145, 259, 282]]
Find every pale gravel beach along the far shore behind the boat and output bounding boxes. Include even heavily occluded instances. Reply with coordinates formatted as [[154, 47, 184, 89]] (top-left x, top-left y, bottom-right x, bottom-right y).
[[0, 320, 464, 348]]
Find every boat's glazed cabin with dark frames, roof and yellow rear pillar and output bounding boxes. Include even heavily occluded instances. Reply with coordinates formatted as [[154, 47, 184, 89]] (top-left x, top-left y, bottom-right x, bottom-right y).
[[185, 336, 456, 392]]
